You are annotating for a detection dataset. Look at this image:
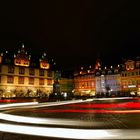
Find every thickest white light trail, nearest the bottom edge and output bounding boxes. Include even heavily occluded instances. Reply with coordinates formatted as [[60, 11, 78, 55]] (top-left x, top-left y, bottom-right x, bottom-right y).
[[0, 123, 140, 140]]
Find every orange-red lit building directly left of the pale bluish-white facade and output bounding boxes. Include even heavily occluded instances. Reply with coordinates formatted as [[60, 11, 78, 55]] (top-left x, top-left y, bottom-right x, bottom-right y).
[[74, 66, 96, 96]]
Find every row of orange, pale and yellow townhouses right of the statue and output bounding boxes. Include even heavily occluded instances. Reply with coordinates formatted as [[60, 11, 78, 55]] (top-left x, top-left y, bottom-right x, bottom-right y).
[[74, 57, 140, 96]]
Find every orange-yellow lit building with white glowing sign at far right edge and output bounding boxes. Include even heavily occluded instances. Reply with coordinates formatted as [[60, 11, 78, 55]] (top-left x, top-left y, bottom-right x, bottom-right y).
[[121, 57, 140, 95]]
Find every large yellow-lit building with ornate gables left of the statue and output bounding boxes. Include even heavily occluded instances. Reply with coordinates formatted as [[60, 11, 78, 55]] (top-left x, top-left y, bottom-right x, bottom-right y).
[[0, 45, 54, 98]]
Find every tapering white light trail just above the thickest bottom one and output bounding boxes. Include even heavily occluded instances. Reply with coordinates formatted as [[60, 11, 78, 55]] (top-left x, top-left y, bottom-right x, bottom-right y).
[[0, 113, 102, 126]]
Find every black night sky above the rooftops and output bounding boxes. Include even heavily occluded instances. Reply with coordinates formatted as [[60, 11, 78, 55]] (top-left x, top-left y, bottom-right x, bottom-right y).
[[0, 0, 140, 68]]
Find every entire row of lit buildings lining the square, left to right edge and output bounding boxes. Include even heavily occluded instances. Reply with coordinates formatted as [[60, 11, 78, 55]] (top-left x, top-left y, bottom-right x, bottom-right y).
[[0, 45, 140, 98]]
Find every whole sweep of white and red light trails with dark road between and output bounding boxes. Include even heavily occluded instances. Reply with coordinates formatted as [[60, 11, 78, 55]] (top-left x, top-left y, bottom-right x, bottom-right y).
[[0, 98, 140, 140]]
